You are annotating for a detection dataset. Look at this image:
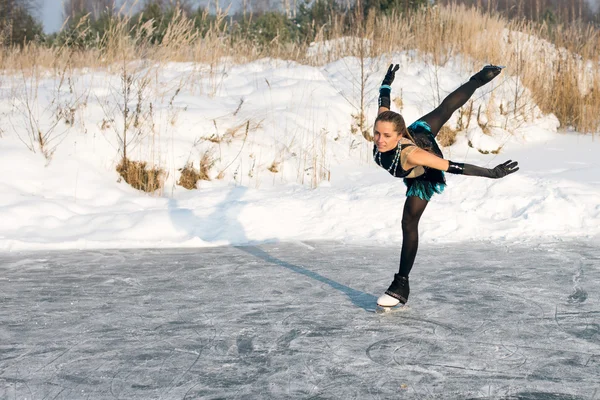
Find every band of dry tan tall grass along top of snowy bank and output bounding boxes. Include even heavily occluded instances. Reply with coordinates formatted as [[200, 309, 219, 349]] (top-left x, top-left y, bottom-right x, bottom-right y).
[[0, 5, 600, 132]]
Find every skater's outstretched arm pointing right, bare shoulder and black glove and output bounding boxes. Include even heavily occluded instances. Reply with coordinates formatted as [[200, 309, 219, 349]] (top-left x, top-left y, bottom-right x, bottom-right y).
[[406, 149, 519, 179]]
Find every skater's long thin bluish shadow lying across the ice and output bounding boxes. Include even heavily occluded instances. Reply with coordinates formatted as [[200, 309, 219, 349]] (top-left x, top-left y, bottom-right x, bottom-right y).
[[237, 246, 377, 312]]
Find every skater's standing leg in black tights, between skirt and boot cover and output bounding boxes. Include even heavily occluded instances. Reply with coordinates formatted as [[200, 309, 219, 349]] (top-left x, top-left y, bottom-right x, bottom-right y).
[[398, 196, 429, 276]]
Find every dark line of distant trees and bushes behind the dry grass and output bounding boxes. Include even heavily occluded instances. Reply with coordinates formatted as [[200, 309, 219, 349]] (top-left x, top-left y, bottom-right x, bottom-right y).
[[0, 0, 599, 47]]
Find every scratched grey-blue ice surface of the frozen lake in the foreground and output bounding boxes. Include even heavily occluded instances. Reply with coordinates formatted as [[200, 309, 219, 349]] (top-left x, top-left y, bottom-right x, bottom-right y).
[[0, 241, 600, 400]]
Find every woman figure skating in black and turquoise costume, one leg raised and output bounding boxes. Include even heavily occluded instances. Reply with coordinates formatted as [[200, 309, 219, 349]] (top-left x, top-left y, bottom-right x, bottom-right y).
[[373, 64, 519, 309]]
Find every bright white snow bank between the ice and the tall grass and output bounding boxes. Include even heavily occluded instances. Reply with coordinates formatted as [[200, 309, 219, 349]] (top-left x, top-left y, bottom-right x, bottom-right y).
[[0, 52, 600, 251]]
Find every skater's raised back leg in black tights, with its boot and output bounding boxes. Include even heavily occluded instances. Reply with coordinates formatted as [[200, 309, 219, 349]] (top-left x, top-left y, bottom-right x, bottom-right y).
[[419, 65, 502, 136]]
